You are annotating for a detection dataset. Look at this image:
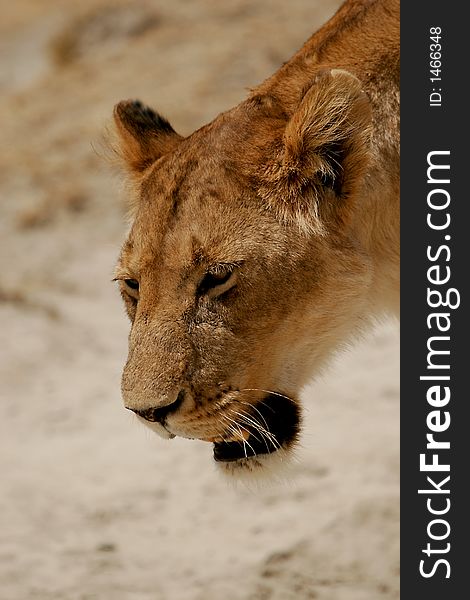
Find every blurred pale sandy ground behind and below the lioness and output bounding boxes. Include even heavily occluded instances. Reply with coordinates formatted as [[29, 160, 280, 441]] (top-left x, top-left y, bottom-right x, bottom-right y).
[[0, 0, 399, 600]]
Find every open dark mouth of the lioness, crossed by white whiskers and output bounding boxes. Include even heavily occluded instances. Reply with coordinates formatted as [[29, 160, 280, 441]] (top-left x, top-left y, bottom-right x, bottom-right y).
[[214, 393, 300, 462]]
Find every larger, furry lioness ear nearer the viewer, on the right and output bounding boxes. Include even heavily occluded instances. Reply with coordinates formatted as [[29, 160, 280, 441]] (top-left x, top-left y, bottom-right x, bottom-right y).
[[264, 70, 372, 230]]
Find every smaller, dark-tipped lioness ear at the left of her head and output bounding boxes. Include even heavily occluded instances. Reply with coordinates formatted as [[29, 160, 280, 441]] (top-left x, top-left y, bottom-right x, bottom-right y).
[[114, 100, 182, 174]]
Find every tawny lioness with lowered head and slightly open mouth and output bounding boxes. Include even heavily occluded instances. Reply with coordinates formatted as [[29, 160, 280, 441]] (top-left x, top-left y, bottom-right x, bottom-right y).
[[114, 0, 399, 474]]
